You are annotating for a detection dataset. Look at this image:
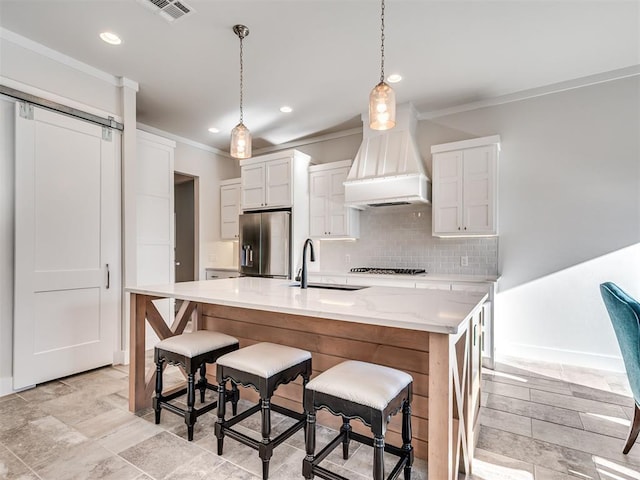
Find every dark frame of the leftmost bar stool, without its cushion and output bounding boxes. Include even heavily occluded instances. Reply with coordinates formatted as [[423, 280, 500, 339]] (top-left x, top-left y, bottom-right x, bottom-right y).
[[153, 343, 240, 441]]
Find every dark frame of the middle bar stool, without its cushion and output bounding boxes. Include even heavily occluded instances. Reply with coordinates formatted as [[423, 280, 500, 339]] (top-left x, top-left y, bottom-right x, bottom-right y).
[[215, 358, 311, 480]]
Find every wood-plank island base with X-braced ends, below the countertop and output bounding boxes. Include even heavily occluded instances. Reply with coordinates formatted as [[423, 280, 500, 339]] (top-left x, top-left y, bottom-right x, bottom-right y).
[[129, 293, 482, 480]]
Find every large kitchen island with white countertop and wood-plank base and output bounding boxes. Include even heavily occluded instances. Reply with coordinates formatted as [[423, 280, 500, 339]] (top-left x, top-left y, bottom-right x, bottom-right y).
[[127, 277, 486, 480]]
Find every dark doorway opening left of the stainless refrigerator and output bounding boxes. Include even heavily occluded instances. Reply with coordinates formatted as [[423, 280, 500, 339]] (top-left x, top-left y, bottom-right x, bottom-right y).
[[173, 172, 199, 282]]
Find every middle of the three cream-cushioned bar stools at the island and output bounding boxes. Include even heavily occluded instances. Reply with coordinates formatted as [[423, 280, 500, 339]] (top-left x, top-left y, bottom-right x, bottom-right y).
[[215, 343, 311, 480]]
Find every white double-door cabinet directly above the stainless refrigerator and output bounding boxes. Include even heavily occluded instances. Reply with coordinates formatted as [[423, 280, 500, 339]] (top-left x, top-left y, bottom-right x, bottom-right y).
[[240, 150, 310, 210]]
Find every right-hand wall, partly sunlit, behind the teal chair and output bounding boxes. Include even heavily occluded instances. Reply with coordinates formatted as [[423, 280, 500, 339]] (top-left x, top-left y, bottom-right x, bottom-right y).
[[418, 76, 640, 370]]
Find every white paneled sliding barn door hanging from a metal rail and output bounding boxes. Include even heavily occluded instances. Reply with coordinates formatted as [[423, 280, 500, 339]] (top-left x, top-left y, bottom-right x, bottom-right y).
[[13, 103, 121, 389]]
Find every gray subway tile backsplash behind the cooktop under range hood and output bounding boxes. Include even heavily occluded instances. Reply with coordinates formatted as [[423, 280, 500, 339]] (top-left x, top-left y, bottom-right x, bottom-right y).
[[319, 205, 498, 275]]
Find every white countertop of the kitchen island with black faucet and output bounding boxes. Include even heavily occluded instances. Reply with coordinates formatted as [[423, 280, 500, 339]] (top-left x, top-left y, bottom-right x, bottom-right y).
[[126, 277, 487, 334]]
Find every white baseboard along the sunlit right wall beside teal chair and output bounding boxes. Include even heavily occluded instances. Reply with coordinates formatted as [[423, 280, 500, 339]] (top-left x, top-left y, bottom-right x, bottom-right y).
[[496, 343, 625, 373]]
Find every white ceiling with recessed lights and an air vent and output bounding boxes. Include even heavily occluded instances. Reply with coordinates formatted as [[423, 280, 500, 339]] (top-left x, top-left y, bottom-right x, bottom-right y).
[[0, 0, 640, 154]]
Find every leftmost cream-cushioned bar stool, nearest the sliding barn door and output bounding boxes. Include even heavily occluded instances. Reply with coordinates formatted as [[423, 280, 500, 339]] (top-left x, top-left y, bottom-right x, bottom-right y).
[[153, 330, 240, 441]]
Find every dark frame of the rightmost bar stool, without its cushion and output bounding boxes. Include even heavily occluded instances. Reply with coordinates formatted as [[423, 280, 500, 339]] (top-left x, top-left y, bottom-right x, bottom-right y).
[[302, 382, 413, 480]]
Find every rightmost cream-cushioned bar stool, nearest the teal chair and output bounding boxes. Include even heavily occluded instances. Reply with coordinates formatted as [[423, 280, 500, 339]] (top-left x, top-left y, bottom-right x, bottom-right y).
[[302, 360, 413, 480]]
